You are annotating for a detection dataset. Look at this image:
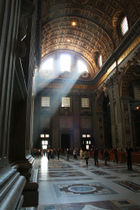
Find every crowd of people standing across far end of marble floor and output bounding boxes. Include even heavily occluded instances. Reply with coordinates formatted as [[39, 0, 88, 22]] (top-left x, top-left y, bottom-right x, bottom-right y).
[[34, 147, 133, 170]]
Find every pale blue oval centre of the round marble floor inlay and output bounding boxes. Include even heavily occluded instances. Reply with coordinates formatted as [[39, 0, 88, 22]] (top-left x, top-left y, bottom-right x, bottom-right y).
[[68, 185, 96, 193]]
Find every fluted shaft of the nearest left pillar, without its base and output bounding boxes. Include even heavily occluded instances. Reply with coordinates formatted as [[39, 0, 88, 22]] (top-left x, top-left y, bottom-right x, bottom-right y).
[[0, 0, 20, 159]]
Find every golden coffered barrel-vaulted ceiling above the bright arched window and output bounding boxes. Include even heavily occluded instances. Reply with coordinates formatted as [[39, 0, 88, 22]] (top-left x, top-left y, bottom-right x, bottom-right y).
[[42, 0, 138, 78]]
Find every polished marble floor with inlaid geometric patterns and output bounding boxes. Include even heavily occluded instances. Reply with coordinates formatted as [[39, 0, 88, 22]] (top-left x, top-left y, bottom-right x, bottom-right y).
[[38, 156, 140, 210]]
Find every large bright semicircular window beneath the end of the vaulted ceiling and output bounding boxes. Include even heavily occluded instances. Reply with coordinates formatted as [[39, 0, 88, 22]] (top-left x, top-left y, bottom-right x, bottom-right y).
[[39, 51, 89, 79]]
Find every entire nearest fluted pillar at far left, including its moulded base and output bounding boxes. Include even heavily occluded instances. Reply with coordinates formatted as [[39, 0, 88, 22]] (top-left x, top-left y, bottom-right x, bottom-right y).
[[0, 0, 25, 210]]
